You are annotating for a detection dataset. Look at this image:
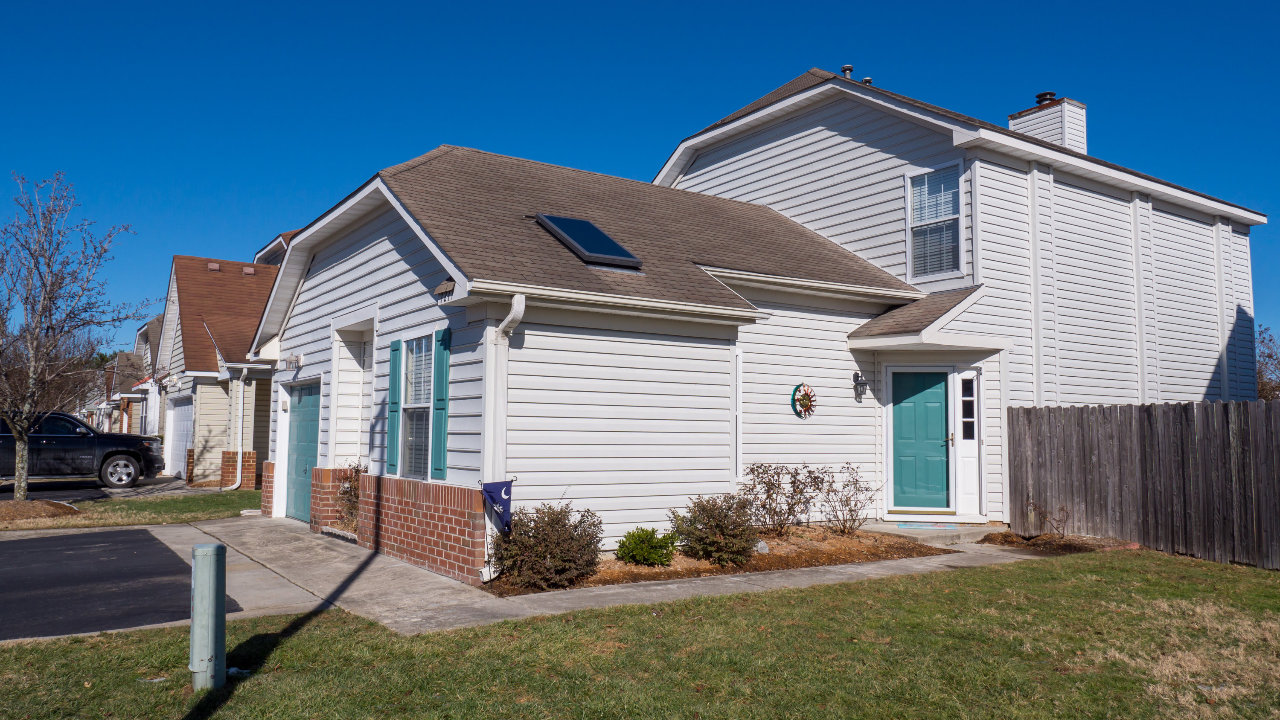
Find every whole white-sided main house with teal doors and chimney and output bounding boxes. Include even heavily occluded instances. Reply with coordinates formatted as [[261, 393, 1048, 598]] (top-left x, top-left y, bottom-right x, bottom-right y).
[[252, 70, 1265, 582]]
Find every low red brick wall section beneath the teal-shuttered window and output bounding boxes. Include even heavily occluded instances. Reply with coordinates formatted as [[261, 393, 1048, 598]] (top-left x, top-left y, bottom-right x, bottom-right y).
[[358, 475, 485, 585]]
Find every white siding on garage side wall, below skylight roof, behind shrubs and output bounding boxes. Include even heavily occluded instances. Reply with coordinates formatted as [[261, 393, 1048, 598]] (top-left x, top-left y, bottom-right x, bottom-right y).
[[507, 316, 733, 546]]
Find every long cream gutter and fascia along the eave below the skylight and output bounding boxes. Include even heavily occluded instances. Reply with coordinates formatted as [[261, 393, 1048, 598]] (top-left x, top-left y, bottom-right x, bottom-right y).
[[460, 279, 769, 325]]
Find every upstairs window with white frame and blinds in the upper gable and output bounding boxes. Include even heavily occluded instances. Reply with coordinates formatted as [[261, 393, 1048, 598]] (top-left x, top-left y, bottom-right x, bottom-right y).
[[910, 167, 960, 278]]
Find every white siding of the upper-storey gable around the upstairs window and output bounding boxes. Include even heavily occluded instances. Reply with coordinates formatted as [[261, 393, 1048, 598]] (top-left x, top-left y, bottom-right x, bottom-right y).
[[675, 99, 970, 291]]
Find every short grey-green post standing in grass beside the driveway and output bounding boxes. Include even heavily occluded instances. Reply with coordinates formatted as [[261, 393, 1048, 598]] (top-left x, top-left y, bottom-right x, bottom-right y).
[[188, 543, 227, 691]]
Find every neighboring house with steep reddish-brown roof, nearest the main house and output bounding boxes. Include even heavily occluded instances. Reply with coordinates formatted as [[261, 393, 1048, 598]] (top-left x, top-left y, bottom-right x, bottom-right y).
[[155, 255, 276, 484]]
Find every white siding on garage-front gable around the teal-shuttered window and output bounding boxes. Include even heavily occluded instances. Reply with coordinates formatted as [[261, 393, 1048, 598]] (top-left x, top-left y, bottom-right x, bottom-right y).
[[271, 203, 484, 487]]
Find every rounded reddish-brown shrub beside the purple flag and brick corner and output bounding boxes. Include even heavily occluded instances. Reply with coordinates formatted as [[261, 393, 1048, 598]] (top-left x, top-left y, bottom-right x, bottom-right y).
[[494, 502, 604, 591]]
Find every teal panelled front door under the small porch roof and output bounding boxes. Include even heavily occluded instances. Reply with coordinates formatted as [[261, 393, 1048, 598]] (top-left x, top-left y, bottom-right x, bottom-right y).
[[893, 373, 951, 509]]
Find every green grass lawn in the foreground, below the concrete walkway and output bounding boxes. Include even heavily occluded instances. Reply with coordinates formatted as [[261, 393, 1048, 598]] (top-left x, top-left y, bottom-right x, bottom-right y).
[[0, 551, 1280, 720]]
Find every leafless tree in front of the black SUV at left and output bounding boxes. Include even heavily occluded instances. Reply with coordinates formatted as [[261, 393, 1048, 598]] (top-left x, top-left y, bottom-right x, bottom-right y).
[[0, 173, 145, 500]]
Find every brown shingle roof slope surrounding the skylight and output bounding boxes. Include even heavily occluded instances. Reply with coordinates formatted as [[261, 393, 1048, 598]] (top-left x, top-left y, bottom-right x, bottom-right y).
[[379, 146, 914, 309]]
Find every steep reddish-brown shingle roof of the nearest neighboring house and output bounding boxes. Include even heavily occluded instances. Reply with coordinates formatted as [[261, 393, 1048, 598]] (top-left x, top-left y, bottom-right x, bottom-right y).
[[173, 255, 279, 373]]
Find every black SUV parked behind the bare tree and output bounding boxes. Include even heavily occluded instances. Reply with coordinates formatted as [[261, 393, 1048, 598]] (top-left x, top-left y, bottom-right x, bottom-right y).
[[0, 413, 164, 488]]
